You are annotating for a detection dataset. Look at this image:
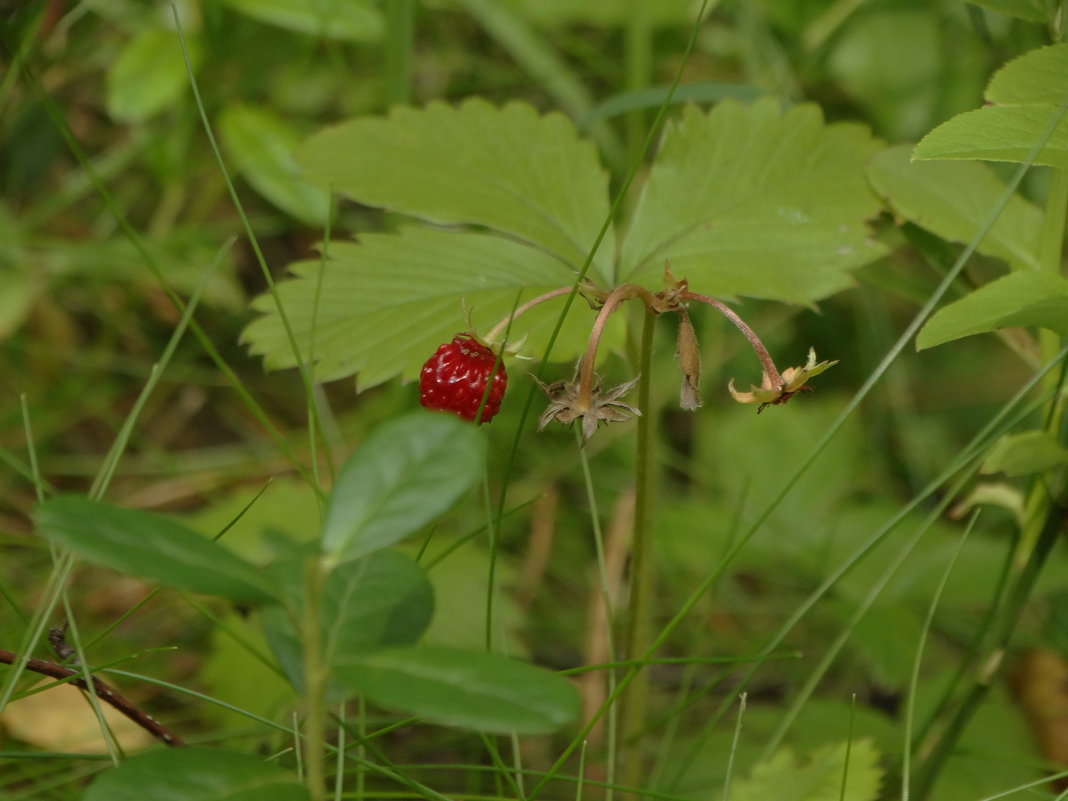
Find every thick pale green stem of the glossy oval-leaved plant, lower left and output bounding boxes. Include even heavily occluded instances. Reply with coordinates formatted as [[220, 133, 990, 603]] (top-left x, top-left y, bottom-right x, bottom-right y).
[[300, 556, 327, 801]]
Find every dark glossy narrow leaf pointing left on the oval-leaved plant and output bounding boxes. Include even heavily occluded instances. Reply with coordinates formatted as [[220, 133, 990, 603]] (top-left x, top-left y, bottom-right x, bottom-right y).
[[34, 496, 273, 603]]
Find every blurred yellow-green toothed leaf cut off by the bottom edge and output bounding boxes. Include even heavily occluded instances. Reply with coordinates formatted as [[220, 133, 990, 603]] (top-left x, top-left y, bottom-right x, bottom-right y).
[[731, 739, 882, 801]]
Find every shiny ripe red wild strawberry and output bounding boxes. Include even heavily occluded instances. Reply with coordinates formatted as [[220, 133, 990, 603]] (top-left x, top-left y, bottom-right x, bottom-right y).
[[419, 333, 508, 423]]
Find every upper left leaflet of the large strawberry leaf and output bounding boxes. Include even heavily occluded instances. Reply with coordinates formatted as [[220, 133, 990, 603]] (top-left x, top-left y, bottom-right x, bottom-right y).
[[298, 98, 613, 283]]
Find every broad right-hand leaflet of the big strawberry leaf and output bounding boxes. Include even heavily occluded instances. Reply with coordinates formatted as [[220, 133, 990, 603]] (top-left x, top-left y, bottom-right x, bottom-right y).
[[623, 98, 881, 303]]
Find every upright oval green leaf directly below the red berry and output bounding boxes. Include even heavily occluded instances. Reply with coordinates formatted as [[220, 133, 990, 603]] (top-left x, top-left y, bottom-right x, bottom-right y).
[[323, 412, 486, 562]]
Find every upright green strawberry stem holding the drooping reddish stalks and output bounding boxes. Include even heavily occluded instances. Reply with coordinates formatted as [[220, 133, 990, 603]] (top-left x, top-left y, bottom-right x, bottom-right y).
[[623, 309, 656, 787]]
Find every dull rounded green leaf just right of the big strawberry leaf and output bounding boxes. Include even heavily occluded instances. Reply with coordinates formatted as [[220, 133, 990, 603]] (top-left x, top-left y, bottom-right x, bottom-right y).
[[868, 145, 1042, 269]]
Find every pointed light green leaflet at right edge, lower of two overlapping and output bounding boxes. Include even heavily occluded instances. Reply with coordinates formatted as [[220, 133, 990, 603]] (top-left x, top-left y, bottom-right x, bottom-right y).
[[912, 106, 1068, 167]]
